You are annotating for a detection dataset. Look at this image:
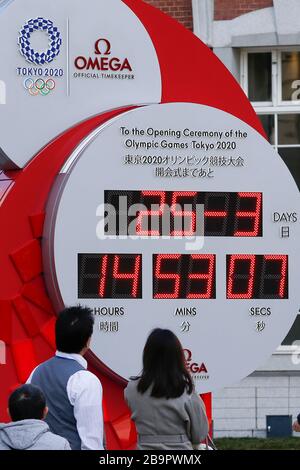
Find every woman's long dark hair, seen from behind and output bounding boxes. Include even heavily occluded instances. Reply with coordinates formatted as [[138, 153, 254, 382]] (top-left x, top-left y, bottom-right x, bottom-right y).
[[138, 328, 194, 398]]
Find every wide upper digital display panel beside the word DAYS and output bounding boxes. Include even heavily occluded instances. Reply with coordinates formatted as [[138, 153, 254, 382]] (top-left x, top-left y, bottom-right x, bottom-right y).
[[104, 190, 263, 237]]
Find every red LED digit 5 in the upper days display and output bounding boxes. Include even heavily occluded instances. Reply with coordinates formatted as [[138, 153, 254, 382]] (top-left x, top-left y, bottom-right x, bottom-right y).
[[171, 191, 197, 237]]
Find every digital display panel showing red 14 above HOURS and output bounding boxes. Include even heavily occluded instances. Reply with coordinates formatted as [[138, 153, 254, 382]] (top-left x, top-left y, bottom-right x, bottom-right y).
[[78, 253, 142, 299]]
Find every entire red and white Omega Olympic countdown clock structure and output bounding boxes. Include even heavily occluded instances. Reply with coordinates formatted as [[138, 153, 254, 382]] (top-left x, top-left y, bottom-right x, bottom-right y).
[[0, 0, 299, 449]]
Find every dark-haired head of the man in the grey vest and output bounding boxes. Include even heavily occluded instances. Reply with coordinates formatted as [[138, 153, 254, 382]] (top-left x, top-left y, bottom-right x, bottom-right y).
[[55, 305, 94, 354]]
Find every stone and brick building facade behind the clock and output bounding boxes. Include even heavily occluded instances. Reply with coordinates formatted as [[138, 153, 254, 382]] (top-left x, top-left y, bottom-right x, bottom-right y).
[[148, 0, 300, 437]]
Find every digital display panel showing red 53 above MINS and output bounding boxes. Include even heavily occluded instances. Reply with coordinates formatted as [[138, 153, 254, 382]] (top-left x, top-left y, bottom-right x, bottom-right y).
[[153, 254, 216, 299]]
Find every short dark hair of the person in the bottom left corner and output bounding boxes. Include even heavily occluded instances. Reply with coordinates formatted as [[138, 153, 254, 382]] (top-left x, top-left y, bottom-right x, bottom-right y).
[[8, 384, 46, 422]]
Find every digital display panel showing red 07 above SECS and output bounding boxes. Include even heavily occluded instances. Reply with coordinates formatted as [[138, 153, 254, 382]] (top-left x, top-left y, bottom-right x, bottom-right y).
[[226, 254, 288, 299]]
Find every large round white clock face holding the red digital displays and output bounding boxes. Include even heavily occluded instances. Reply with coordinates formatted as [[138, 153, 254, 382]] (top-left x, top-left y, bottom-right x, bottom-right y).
[[44, 103, 300, 392]]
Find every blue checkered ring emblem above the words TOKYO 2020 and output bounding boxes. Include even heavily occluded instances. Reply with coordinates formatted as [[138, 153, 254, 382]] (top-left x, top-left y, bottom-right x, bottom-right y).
[[18, 18, 62, 65]]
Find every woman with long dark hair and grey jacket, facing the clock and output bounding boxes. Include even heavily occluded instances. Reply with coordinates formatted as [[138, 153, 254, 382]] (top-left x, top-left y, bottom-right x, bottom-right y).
[[124, 328, 208, 450]]
